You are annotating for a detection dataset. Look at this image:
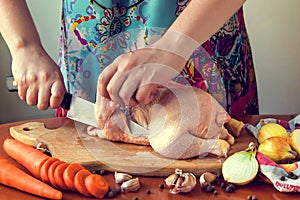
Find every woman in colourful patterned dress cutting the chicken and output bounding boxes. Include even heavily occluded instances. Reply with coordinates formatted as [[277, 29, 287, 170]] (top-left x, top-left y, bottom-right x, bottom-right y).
[[0, 0, 258, 122]]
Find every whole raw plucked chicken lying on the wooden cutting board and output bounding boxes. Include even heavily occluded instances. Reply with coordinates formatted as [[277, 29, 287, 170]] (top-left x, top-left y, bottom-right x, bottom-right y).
[[88, 86, 244, 159]]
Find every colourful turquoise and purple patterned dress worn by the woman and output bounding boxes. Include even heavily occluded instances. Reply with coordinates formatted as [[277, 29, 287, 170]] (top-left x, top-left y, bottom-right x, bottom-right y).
[[57, 0, 258, 116]]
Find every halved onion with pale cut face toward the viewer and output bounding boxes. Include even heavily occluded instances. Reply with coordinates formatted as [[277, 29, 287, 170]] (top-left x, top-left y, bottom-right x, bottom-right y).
[[222, 143, 259, 185]]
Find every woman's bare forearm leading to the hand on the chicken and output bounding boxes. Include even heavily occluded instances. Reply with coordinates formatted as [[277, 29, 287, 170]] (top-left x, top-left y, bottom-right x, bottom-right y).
[[151, 0, 246, 63]]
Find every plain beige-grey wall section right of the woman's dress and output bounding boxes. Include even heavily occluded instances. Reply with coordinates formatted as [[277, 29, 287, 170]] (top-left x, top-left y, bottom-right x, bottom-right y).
[[245, 0, 300, 114]]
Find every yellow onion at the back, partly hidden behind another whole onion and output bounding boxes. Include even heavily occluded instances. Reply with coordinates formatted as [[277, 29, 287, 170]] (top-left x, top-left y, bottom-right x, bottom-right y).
[[257, 123, 289, 143]]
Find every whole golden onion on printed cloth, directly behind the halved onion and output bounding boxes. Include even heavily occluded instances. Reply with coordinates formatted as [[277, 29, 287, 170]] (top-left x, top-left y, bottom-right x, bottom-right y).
[[258, 137, 297, 162]]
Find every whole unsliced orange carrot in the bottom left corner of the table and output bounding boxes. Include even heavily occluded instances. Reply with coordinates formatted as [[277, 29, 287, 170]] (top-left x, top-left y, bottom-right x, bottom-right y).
[[0, 157, 62, 199]]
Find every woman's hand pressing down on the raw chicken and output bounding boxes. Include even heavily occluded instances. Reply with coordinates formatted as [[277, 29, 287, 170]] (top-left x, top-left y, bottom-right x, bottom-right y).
[[98, 47, 185, 106]]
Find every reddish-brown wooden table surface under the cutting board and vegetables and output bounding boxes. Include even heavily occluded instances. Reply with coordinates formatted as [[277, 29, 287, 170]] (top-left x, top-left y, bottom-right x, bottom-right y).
[[0, 115, 300, 200]]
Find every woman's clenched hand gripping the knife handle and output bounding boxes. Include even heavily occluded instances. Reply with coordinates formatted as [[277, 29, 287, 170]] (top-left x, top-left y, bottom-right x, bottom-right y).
[[12, 46, 66, 110]]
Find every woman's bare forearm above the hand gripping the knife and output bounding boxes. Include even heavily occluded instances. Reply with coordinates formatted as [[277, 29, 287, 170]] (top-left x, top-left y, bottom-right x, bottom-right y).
[[0, 0, 41, 56]]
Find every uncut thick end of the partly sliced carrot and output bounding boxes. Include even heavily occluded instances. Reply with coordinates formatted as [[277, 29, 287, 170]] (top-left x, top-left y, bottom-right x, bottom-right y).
[[3, 138, 49, 178]]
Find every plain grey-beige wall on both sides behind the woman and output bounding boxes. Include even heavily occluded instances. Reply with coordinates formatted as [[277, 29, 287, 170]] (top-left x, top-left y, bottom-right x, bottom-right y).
[[0, 0, 300, 123]]
